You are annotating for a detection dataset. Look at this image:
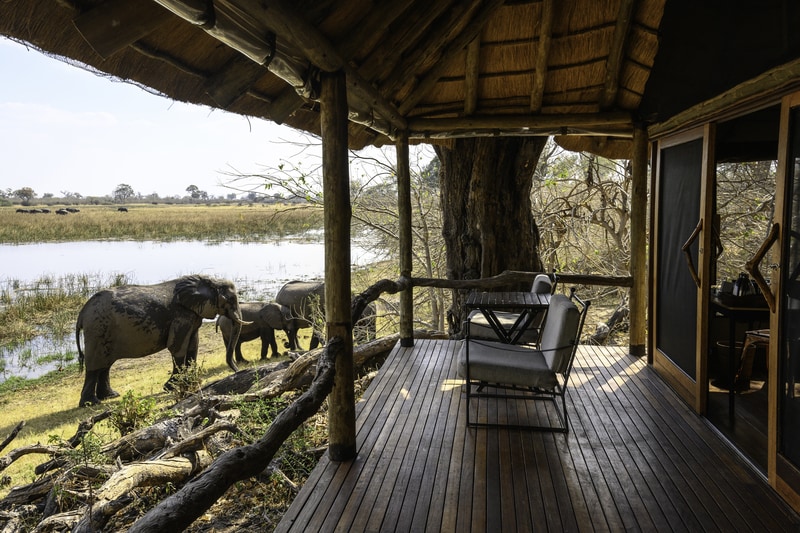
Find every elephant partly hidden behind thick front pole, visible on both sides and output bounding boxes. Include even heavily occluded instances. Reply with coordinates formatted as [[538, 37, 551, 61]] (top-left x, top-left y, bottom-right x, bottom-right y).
[[275, 281, 376, 350]]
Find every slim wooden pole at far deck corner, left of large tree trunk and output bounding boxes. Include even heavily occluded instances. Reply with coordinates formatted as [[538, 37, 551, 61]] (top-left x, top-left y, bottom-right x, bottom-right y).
[[396, 132, 414, 348]]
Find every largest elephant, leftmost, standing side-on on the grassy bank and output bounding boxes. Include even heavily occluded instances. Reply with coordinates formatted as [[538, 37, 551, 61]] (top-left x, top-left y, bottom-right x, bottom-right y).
[[75, 275, 243, 406]]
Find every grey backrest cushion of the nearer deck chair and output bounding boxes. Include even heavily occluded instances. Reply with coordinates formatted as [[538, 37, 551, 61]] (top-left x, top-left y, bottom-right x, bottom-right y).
[[539, 294, 581, 373]]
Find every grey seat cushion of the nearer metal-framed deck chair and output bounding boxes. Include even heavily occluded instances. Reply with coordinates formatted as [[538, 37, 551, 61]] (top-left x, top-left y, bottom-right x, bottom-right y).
[[458, 341, 558, 389]]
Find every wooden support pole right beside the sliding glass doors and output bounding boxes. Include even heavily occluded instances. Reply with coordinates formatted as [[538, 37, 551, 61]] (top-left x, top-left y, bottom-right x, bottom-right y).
[[629, 126, 648, 357]]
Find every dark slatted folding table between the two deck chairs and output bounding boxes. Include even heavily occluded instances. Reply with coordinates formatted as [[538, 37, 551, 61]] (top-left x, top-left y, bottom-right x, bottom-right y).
[[465, 291, 550, 344]]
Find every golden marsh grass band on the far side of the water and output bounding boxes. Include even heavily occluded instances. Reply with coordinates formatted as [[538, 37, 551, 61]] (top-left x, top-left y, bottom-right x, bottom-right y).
[[0, 204, 322, 244]]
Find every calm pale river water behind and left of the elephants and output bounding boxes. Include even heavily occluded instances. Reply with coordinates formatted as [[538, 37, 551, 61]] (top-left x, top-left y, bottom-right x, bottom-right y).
[[0, 235, 378, 382]]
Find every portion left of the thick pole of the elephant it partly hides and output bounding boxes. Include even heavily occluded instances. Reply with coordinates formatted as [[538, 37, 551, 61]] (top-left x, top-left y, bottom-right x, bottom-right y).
[[275, 281, 325, 350]]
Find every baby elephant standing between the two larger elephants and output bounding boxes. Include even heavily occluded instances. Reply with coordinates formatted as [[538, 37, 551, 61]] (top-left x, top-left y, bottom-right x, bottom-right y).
[[217, 302, 289, 363]]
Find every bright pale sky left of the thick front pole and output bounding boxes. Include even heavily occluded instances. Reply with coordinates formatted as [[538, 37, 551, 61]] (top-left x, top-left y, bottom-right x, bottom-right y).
[[0, 37, 319, 198]]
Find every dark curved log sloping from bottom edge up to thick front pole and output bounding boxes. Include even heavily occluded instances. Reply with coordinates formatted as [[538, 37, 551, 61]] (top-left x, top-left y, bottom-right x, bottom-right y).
[[129, 337, 344, 533]]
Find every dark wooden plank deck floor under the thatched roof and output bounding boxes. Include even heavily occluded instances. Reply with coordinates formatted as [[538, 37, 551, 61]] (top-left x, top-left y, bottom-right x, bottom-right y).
[[278, 340, 800, 532]]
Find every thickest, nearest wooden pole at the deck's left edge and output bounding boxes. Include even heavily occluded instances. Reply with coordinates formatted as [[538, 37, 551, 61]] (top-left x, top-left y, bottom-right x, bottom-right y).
[[320, 71, 356, 461]]
